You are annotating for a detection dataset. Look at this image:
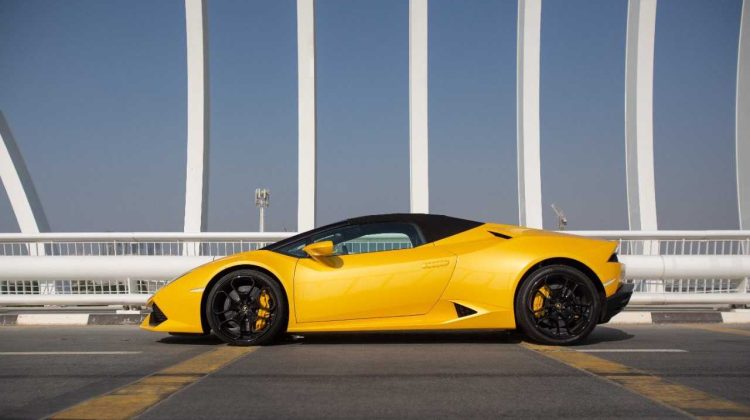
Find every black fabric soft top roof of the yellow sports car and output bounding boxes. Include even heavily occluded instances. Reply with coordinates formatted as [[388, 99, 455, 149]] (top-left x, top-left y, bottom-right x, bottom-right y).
[[263, 213, 483, 251]]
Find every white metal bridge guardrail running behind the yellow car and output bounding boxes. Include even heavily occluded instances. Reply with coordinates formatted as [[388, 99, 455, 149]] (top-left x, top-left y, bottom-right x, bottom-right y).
[[0, 231, 750, 305]]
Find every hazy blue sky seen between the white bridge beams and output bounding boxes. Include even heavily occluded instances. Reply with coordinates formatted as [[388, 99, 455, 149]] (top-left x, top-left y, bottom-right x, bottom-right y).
[[0, 0, 742, 232]]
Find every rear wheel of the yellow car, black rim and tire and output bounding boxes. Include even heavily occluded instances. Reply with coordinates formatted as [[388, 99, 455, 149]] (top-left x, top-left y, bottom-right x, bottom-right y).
[[514, 265, 601, 345]]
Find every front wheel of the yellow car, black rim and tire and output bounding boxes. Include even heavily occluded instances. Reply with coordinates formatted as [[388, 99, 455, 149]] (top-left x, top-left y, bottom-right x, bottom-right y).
[[206, 269, 289, 346]]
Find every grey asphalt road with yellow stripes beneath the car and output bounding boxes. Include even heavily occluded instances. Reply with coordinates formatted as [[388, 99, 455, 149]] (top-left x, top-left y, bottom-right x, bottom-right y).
[[0, 324, 750, 419]]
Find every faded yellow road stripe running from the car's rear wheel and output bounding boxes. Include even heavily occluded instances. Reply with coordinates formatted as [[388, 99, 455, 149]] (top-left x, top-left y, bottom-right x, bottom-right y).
[[521, 343, 750, 418]]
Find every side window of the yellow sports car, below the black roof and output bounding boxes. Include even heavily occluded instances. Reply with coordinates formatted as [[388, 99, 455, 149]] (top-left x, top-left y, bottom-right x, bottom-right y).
[[279, 222, 424, 258]]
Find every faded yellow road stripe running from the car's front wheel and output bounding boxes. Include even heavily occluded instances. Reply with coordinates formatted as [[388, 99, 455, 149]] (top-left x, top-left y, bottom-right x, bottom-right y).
[[51, 346, 257, 419]]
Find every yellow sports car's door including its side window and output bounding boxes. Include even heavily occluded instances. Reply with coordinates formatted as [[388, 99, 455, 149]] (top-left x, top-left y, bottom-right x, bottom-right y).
[[294, 223, 456, 322]]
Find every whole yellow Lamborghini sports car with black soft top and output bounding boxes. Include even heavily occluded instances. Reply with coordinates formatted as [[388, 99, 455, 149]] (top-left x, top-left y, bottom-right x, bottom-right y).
[[141, 214, 633, 345]]
